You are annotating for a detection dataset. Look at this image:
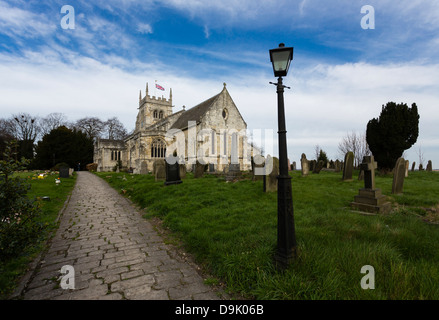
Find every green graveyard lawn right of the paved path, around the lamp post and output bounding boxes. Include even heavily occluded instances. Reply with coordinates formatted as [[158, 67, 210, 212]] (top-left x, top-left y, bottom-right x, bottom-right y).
[[97, 170, 439, 300]]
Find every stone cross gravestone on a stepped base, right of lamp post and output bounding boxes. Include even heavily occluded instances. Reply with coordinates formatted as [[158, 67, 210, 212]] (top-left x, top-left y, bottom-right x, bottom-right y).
[[351, 156, 391, 213]]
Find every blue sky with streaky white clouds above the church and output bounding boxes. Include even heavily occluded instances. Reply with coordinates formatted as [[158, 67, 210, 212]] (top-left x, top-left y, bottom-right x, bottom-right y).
[[0, 0, 439, 168]]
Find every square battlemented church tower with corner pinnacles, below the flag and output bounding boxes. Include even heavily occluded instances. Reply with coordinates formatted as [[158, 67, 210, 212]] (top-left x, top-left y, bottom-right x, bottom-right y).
[[136, 83, 172, 131]]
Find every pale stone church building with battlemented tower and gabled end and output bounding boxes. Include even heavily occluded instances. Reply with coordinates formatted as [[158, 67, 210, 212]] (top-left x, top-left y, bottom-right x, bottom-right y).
[[94, 83, 252, 173]]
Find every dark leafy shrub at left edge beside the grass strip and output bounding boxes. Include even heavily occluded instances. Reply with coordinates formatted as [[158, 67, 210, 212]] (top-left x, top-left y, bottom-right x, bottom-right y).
[[0, 143, 43, 260]]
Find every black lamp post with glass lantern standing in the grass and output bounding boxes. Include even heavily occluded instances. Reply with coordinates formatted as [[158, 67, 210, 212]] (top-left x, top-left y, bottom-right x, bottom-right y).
[[270, 43, 296, 269]]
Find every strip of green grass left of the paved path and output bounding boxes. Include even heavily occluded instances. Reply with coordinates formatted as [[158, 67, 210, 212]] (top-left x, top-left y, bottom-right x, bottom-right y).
[[0, 172, 76, 299]]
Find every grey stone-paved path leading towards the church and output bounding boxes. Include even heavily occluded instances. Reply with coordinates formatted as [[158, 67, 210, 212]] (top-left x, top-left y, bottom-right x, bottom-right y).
[[22, 171, 227, 300]]
